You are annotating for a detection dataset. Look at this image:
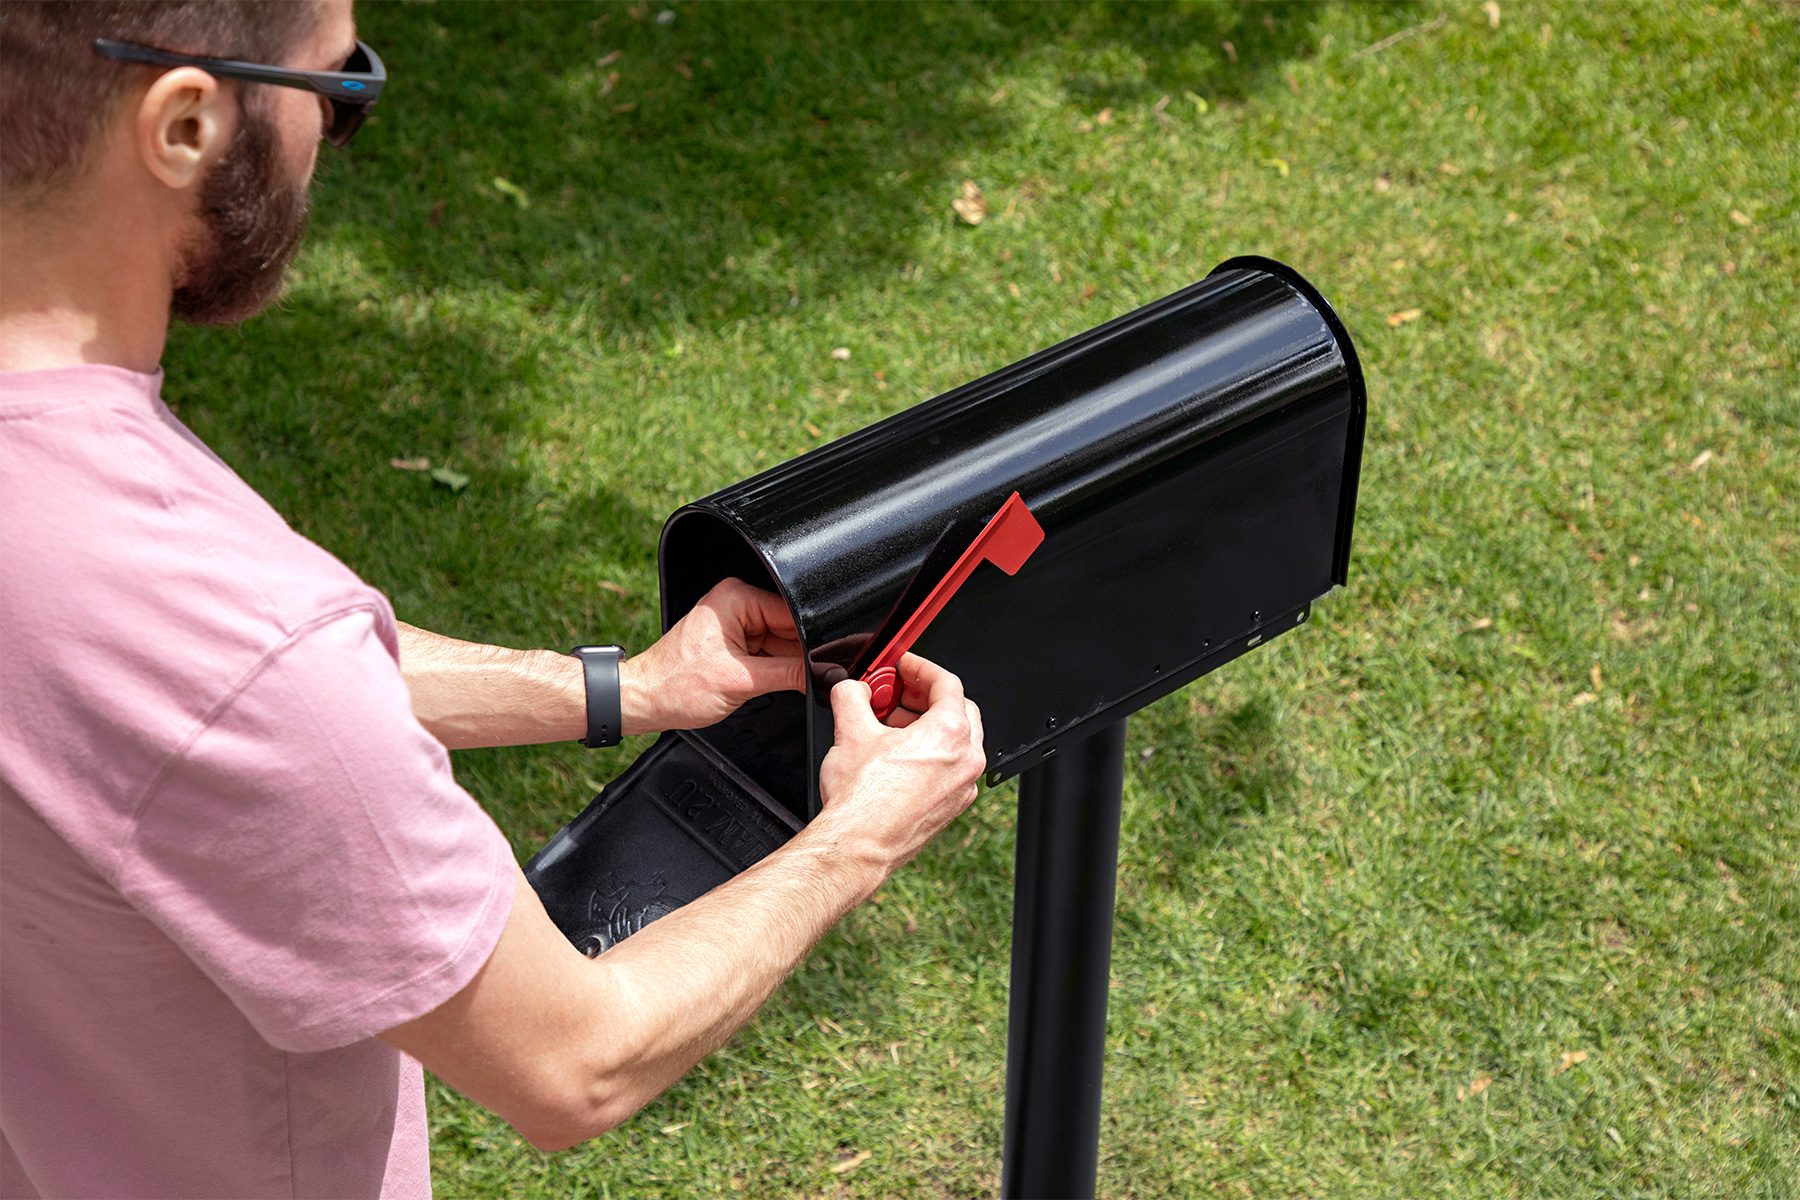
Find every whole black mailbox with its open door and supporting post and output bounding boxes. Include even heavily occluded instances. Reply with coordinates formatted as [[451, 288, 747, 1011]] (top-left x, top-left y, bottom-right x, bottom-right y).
[[526, 257, 1364, 1196]]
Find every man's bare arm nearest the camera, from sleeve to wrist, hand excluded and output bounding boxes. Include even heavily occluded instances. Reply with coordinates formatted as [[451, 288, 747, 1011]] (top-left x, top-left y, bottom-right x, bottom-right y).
[[399, 810, 893, 1150]]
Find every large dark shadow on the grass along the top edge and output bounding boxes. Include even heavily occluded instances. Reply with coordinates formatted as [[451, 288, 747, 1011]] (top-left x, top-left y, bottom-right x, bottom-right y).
[[315, 4, 1339, 335]]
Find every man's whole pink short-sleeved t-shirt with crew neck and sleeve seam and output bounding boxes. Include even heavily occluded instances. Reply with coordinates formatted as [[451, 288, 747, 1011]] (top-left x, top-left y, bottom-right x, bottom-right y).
[[0, 367, 515, 1196]]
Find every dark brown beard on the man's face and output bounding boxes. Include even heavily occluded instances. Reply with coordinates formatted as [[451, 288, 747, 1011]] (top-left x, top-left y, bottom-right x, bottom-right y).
[[169, 106, 306, 326]]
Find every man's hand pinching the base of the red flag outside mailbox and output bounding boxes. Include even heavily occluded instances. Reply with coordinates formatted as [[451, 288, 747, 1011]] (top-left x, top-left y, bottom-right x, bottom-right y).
[[812, 655, 986, 874]]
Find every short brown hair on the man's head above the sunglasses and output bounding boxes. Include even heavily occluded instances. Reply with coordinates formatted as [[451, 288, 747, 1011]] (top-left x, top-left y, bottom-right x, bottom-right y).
[[0, 0, 319, 200]]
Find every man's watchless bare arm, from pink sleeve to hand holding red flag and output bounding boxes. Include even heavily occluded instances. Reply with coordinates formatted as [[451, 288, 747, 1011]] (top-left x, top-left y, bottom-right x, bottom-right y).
[[370, 655, 985, 1150]]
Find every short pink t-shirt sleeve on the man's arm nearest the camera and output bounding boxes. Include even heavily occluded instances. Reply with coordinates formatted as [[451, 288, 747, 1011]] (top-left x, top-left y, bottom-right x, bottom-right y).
[[121, 610, 515, 1051]]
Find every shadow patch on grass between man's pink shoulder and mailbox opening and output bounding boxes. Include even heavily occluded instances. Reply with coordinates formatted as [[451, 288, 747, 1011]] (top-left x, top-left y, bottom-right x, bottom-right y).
[[167, 288, 662, 646]]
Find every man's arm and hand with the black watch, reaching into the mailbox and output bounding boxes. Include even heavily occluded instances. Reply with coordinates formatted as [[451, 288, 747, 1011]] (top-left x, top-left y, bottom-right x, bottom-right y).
[[400, 579, 806, 750]]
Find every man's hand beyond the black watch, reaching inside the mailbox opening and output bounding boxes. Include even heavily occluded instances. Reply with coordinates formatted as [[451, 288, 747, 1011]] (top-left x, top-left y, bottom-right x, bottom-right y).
[[619, 579, 806, 734]]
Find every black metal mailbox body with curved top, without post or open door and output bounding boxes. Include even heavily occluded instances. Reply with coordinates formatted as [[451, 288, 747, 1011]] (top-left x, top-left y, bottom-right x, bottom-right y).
[[661, 259, 1366, 817]]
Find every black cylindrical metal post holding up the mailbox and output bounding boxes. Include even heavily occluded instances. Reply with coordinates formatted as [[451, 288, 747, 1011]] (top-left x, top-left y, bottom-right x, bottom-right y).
[[1001, 721, 1125, 1200]]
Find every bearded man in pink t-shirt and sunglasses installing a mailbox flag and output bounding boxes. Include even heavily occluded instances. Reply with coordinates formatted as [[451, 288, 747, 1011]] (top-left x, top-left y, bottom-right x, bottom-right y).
[[0, 0, 983, 1196]]
